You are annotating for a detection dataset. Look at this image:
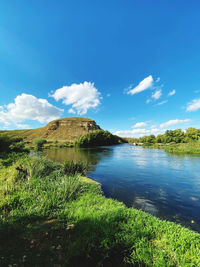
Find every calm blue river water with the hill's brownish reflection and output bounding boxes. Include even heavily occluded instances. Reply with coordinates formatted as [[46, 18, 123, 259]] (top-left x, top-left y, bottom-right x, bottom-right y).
[[45, 144, 200, 231]]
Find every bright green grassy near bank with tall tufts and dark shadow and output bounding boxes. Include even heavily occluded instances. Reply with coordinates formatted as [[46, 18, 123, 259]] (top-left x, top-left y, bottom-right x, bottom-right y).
[[0, 156, 200, 267]]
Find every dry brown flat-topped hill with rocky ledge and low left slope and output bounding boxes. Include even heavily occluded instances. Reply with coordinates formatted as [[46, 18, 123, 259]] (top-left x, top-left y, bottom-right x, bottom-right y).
[[0, 117, 101, 142]]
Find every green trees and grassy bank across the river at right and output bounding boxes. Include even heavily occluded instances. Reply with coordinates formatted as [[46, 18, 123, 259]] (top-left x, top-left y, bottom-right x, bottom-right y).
[[125, 128, 200, 155]]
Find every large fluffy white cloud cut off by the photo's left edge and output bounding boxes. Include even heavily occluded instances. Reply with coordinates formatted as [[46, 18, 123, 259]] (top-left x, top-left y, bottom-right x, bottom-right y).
[[0, 94, 63, 128]]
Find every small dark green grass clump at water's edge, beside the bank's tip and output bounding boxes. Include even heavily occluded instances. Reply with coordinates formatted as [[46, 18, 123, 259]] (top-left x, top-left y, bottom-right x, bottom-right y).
[[63, 160, 88, 176]]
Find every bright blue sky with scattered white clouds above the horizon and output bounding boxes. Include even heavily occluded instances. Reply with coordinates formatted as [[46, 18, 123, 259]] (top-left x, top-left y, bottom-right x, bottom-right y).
[[0, 0, 200, 136]]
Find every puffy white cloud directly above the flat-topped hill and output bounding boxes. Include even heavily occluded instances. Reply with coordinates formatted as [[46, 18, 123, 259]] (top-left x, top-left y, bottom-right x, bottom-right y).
[[51, 81, 101, 115]]
